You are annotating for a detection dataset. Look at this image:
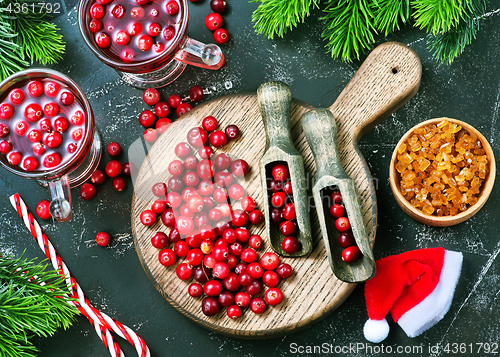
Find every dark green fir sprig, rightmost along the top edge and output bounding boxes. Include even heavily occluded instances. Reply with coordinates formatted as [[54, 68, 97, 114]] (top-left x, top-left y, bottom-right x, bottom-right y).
[[427, 0, 486, 64]]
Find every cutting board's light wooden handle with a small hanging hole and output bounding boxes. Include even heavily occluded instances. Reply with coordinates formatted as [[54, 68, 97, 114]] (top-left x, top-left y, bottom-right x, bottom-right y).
[[328, 42, 422, 140]]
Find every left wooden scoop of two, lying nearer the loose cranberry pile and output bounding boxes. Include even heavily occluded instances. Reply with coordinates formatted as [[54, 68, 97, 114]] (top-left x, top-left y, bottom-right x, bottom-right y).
[[257, 82, 312, 257]]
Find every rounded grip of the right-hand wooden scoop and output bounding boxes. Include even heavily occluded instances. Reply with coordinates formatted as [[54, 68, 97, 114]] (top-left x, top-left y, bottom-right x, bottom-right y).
[[302, 109, 349, 180]]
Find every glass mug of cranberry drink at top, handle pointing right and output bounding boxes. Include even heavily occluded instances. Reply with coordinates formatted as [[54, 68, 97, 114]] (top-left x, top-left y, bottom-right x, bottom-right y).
[[78, 0, 225, 88]]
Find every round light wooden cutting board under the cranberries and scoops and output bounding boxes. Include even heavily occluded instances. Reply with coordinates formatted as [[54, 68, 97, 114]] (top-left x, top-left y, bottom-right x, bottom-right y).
[[129, 43, 421, 338]]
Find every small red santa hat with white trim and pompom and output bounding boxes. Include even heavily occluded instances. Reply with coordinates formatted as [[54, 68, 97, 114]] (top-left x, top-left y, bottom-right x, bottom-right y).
[[363, 248, 462, 343]]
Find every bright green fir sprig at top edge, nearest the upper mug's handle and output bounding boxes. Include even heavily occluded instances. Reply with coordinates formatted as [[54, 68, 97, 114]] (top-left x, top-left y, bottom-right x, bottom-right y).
[[250, 0, 318, 39]]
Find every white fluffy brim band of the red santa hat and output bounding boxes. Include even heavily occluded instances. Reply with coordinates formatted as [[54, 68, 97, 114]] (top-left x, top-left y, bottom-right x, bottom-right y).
[[398, 250, 463, 337]]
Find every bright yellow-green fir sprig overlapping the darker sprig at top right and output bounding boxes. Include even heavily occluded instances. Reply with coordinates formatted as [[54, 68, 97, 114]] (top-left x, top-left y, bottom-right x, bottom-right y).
[[412, 0, 469, 35]]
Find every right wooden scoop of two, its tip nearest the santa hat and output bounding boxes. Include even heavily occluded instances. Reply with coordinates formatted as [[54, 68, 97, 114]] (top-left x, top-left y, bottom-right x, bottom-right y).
[[302, 109, 375, 283]]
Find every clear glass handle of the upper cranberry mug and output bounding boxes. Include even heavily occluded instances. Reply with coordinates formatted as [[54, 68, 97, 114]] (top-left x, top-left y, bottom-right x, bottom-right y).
[[174, 37, 225, 69]]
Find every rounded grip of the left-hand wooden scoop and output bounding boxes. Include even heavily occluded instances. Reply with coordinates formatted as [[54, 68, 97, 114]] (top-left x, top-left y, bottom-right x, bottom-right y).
[[257, 81, 299, 155]]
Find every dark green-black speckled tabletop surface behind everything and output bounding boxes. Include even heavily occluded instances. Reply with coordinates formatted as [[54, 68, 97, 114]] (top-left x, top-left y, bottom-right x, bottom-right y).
[[0, 0, 500, 357]]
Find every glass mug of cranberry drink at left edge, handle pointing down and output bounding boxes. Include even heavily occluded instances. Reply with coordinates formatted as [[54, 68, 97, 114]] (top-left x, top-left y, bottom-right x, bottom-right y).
[[0, 69, 101, 222]]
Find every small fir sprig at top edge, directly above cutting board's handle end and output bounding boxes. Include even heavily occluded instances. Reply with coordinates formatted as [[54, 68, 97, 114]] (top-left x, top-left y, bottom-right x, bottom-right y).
[[374, 0, 411, 36]]
